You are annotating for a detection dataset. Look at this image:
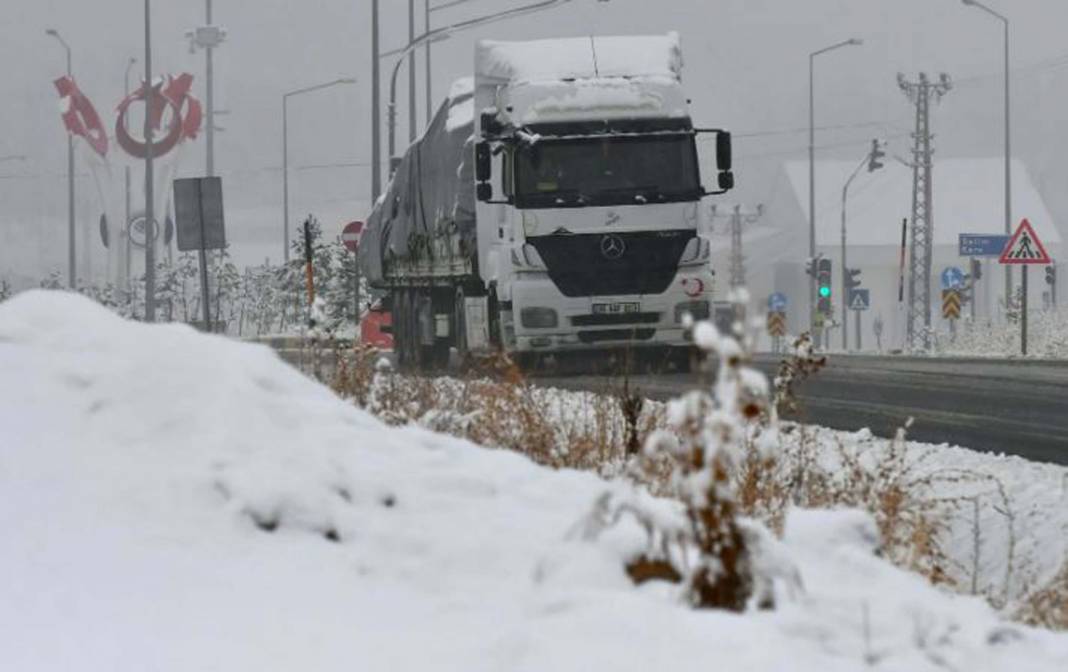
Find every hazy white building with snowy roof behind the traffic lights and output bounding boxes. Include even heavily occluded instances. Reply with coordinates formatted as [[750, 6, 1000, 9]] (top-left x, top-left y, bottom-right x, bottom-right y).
[[713, 158, 1063, 349]]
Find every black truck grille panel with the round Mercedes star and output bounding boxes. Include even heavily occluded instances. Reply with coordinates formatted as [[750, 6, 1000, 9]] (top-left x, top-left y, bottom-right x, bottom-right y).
[[528, 230, 696, 297]]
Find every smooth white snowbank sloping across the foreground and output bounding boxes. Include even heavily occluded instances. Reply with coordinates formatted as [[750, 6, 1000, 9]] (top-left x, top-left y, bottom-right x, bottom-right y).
[[6, 291, 1068, 672]]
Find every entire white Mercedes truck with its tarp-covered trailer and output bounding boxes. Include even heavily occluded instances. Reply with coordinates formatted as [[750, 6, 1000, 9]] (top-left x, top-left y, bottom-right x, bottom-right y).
[[360, 33, 734, 369]]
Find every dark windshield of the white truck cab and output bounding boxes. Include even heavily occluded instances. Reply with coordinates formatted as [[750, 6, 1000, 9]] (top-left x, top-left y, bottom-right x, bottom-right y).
[[515, 134, 701, 208]]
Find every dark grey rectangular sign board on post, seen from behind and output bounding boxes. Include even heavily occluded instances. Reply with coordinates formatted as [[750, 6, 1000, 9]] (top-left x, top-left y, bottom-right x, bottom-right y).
[[174, 177, 226, 332]]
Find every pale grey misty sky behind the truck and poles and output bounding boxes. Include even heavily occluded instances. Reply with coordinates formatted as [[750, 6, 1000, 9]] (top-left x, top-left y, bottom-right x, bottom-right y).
[[0, 0, 1068, 286]]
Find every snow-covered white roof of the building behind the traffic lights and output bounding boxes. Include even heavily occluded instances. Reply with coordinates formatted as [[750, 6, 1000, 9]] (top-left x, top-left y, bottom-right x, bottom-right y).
[[775, 158, 1061, 247]]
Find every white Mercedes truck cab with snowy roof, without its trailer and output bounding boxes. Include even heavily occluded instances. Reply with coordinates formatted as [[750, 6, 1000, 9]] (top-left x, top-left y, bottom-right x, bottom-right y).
[[474, 34, 733, 361]]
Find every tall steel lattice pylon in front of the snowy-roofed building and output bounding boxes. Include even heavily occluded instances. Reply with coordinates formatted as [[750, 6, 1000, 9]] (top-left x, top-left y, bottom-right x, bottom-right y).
[[897, 73, 953, 351]]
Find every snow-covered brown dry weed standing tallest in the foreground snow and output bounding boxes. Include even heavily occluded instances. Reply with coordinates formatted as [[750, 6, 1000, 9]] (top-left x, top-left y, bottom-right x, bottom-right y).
[[595, 316, 775, 611]]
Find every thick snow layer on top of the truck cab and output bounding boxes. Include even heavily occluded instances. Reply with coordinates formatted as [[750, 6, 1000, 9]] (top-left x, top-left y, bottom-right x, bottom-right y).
[[475, 32, 682, 83]]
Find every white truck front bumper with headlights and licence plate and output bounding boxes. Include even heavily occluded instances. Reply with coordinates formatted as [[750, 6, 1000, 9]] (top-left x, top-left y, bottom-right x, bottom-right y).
[[502, 267, 712, 354]]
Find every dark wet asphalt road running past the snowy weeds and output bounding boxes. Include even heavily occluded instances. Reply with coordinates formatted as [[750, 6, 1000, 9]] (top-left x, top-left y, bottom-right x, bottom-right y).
[[539, 355, 1068, 465]]
